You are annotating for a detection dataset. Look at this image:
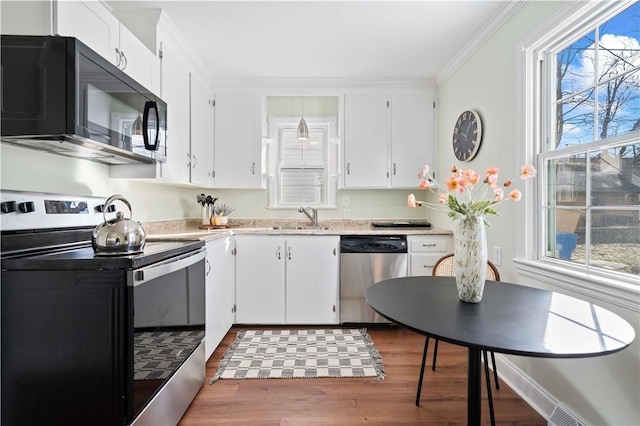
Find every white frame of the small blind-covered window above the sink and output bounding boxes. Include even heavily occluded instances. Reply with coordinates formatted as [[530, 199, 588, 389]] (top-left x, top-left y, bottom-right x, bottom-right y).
[[267, 116, 340, 209]]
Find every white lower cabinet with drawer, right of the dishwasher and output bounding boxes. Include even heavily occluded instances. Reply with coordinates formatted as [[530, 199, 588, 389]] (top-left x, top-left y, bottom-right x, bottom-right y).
[[407, 235, 453, 277]]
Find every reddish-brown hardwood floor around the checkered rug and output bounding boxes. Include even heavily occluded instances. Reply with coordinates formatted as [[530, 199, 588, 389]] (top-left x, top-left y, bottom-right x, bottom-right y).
[[179, 326, 547, 426]]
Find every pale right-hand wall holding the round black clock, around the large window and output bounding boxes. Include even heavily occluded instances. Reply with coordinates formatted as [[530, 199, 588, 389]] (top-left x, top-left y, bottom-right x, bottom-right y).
[[433, 1, 640, 425]]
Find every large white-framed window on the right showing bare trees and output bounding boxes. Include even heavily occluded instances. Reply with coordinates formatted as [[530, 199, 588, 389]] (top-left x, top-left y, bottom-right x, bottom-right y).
[[520, 2, 640, 304]]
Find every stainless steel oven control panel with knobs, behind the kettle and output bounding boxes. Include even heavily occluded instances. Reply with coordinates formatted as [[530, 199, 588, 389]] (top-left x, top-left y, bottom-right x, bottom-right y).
[[0, 191, 116, 231]]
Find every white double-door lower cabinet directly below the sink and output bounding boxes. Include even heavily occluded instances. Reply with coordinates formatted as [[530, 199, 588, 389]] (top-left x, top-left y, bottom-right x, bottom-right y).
[[236, 235, 340, 324]]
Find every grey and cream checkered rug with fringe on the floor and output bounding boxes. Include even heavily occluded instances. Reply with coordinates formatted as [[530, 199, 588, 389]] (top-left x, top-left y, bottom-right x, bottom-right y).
[[210, 329, 385, 383]]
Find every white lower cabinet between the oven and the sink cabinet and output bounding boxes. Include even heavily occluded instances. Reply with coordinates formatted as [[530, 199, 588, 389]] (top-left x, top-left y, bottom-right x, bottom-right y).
[[205, 236, 236, 359]]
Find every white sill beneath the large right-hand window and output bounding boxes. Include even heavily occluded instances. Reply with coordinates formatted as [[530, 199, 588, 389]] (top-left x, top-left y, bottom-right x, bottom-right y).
[[514, 259, 640, 312]]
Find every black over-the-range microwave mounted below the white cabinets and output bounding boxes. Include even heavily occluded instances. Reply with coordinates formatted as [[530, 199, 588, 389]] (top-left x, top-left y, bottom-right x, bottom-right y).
[[0, 35, 167, 164]]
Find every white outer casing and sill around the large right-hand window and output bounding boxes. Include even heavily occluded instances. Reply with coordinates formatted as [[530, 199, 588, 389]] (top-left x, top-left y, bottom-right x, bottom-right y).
[[514, 1, 640, 312]]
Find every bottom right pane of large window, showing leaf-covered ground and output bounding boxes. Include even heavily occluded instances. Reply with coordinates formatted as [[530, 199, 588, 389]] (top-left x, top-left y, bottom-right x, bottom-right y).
[[588, 208, 640, 275]]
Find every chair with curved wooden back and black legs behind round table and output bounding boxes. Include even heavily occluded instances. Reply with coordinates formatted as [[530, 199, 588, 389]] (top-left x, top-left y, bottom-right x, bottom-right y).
[[416, 253, 500, 426]]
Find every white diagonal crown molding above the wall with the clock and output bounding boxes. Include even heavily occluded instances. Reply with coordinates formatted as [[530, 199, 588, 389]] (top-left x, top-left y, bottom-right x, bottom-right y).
[[436, 0, 528, 87]]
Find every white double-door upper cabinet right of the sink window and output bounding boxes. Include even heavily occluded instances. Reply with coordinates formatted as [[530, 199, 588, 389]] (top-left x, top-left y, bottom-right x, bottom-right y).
[[343, 89, 434, 188]]
